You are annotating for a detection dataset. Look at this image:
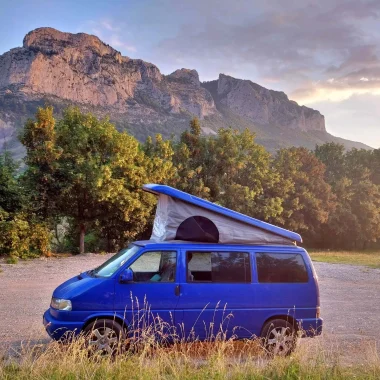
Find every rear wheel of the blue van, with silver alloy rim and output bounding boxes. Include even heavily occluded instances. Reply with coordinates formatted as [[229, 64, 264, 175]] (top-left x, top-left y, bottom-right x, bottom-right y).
[[261, 319, 297, 356]]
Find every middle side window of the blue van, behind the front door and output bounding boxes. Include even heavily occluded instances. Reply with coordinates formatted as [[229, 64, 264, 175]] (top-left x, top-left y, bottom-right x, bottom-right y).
[[186, 251, 251, 283]]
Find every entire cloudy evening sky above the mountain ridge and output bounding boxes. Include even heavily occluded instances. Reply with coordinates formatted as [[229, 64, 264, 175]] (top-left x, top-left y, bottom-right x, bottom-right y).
[[0, 0, 380, 148]]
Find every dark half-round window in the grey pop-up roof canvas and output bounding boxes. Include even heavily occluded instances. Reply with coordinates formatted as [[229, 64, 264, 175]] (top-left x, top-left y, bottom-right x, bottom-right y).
[[175, 215, 219, 243]]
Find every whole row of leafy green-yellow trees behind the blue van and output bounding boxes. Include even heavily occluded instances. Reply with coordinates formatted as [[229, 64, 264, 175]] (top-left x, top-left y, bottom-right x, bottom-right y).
[[0, 107, 380, 257]]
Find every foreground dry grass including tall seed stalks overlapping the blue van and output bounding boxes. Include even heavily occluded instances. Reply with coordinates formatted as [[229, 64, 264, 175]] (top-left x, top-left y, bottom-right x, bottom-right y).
[[0, 294, 380, 380]]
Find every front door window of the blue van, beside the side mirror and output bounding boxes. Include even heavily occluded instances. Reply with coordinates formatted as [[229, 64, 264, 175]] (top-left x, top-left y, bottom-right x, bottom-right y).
[[130, 251, 177, 282]]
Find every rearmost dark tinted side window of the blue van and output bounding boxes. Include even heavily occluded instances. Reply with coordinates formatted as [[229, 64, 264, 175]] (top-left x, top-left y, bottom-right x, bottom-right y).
[[256, 253, 308, 283]]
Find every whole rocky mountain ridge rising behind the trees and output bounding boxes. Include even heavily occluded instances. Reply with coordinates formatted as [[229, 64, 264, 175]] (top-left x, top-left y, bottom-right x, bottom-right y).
[[0, 28, 366, 154]]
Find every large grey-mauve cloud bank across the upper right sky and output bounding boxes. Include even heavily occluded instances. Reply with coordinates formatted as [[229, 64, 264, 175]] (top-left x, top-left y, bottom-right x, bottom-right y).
[[156, 0, 380, 98]]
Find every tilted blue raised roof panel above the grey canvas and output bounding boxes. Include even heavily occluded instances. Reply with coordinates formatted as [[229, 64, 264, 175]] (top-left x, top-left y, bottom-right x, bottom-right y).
[[143, 184, 302, 243]]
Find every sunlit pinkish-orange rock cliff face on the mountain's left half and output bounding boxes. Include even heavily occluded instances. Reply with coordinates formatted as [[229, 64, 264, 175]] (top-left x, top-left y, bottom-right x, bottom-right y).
[[0, 28, 214, 118]]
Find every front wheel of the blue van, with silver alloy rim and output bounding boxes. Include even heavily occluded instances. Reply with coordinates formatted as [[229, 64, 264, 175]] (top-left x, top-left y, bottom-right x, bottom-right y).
[[83, 319, 125, 355]]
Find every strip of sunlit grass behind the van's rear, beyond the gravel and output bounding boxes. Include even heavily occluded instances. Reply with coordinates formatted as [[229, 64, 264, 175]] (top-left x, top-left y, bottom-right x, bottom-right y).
[[309, 250, 380, 268]]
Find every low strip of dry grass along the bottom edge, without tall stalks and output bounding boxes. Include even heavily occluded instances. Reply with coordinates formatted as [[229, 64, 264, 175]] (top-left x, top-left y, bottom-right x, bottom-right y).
[[0, 341, 380, 380]]
